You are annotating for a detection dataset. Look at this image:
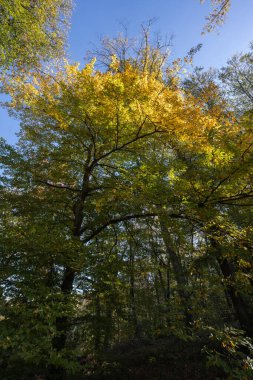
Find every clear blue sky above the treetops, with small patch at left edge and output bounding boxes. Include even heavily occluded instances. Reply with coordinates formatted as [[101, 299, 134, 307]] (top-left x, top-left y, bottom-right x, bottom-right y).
[[0, 0, 253, 144]]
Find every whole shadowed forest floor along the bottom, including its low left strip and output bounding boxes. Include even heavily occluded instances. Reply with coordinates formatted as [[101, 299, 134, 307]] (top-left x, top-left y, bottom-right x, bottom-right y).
[[2, 336, 228, 380]]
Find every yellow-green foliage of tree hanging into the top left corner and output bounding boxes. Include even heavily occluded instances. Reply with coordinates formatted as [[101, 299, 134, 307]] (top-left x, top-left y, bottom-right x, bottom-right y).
[[0, 0, 72, 71]]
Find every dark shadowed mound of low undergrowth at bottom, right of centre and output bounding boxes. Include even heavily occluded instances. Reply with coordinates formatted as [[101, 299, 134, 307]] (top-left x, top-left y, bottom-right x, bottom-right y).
[[84, 337, 225, 380]]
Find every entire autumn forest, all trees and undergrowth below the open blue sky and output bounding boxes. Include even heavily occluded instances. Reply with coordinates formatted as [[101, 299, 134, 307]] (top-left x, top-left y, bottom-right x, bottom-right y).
[[0, 0, 253, 380]]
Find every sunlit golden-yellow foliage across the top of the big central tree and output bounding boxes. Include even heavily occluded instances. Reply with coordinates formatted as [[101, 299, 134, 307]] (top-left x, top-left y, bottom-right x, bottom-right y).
[[4, 57, 240, 160]]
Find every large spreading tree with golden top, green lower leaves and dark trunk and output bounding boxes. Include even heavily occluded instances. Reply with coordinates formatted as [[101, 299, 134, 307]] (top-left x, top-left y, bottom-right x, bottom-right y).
[[0, 37, 252, 378]]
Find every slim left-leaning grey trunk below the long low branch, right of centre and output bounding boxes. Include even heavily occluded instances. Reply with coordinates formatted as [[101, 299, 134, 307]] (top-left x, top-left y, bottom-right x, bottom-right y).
[[159, 215, 192, 326]]
